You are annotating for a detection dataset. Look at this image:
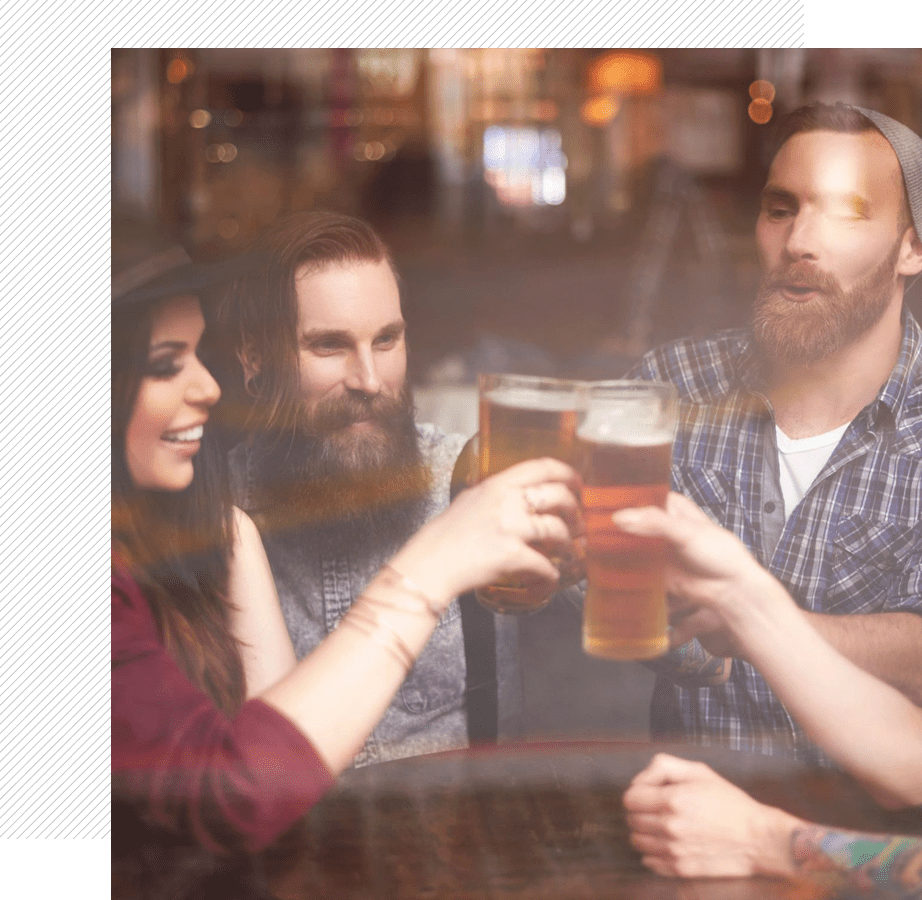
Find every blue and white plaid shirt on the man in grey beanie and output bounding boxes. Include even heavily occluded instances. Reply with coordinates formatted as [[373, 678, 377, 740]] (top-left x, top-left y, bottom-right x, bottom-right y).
[[631, 312, 922, 765]]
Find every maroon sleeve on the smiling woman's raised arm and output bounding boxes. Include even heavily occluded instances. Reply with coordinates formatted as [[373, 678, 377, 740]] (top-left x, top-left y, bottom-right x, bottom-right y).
[[112, 564, 333, 852]]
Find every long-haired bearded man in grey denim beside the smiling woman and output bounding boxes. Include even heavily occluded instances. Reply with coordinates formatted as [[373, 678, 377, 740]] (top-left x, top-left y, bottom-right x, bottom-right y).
[[216, 211, 521, 766]]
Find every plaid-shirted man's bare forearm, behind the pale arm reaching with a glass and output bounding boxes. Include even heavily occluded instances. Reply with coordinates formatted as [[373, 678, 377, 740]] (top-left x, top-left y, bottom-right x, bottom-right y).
[[804, 612, 922, 706]]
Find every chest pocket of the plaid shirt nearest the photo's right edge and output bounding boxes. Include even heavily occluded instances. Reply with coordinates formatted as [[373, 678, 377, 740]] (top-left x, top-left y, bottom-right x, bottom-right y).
[[823, 514, 922, 614]]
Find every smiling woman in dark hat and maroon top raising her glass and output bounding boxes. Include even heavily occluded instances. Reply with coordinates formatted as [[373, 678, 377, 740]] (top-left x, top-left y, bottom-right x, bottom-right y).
[[112, 248, 578, 851]]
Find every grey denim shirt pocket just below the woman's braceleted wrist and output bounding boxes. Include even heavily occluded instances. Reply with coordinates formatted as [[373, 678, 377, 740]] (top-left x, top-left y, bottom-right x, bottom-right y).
[[400, 601, 467, 715]]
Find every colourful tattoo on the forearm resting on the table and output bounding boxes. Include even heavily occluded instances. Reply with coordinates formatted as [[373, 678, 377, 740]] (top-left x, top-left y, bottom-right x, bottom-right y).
[[791, 825, 922, 898]]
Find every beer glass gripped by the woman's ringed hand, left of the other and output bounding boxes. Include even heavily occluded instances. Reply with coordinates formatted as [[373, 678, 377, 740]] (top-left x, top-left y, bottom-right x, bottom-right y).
[[477, 374, 583, 615]]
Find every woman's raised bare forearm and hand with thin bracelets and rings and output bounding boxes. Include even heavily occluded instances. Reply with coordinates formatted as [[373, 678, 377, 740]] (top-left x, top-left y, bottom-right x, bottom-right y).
[[262, 459, 578, 774]]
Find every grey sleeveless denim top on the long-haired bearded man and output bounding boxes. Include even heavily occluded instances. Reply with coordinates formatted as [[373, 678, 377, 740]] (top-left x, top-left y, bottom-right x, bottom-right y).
[[230, 425, 521, 766]]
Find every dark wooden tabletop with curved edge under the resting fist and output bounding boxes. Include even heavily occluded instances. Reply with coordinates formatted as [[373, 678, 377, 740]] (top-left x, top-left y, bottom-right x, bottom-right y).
[[258, 742, 922, 900]]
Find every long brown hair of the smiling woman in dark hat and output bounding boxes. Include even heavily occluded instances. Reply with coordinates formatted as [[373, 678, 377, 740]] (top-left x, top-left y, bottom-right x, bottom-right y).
[[112, 296, 245, 715]]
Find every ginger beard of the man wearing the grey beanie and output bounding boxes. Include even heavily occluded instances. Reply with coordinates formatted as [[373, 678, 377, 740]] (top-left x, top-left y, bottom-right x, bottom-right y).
[[753, 242, 900, 365]]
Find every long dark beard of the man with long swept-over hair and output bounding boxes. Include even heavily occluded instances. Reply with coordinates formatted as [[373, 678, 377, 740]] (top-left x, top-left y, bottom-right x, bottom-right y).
[[256, 384, 430, 543]]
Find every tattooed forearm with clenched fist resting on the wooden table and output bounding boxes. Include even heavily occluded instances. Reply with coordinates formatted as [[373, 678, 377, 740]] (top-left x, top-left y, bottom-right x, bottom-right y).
[[624, 753, 922, 898]]
